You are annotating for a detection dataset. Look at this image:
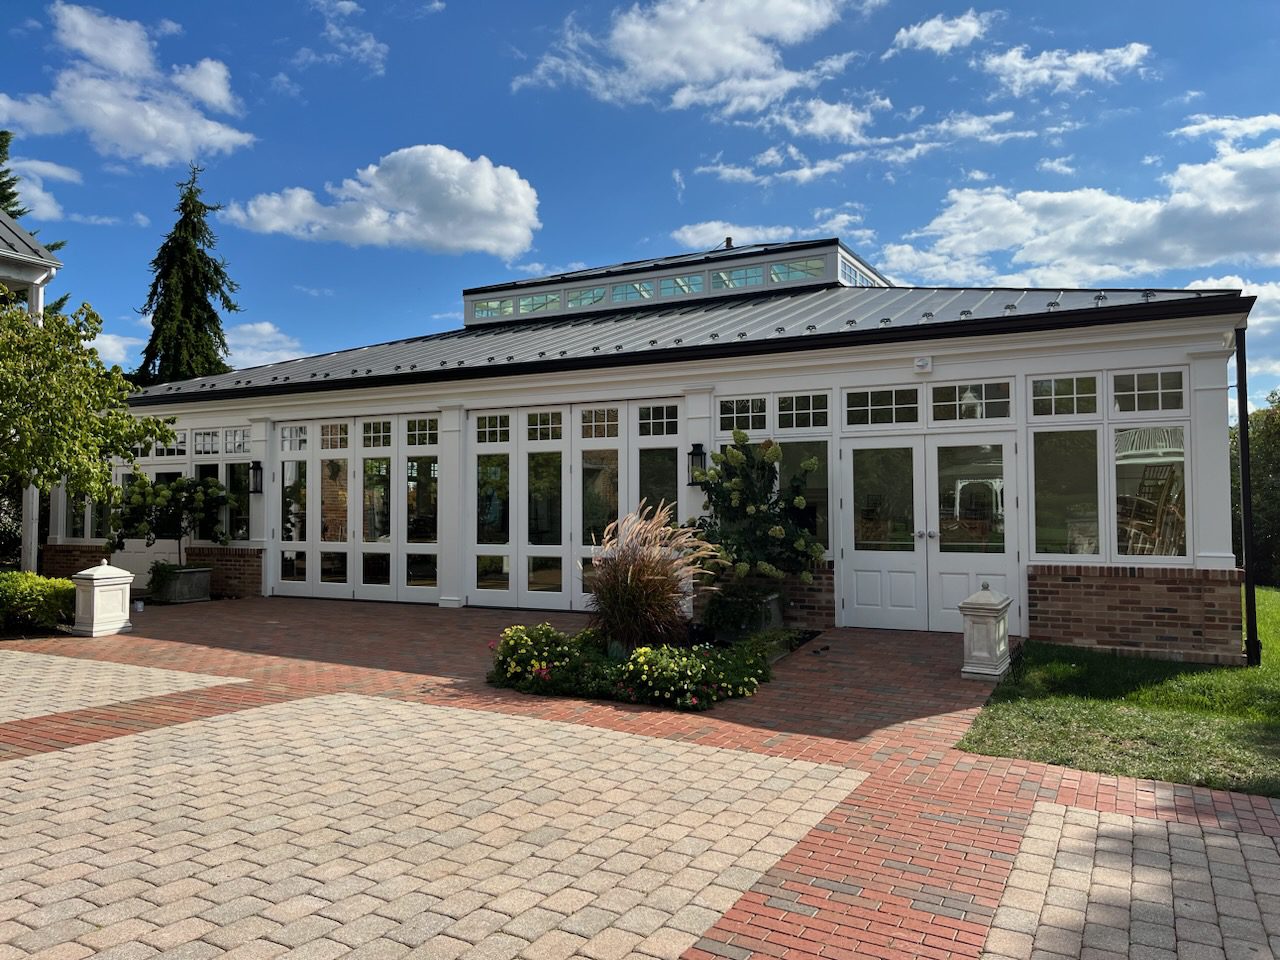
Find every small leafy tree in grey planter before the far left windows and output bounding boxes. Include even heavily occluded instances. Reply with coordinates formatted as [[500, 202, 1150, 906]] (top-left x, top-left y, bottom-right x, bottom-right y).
[[108, 475, 230, 603]]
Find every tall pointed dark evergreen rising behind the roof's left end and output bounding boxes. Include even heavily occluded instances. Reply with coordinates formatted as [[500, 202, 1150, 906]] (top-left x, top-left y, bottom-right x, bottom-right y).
[[133, 164, 239, 384]]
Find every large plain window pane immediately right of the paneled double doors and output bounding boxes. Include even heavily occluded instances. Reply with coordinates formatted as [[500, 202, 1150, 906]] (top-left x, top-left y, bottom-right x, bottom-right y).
[[1033, 430, 1098, 556]]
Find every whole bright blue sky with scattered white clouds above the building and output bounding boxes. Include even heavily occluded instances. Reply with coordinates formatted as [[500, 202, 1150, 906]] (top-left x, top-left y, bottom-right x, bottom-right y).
[[0, 0, 1280, 409]]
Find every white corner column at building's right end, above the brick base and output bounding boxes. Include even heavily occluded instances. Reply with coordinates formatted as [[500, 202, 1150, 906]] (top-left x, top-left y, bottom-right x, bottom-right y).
[[1187, 351, 1235, 570]]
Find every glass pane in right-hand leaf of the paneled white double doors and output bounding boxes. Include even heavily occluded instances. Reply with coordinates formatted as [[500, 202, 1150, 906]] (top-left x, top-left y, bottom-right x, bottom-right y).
[[938, 443, 1005, 553]]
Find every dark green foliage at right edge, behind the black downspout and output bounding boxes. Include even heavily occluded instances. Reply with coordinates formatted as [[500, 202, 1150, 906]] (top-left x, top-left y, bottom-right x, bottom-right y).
[[1231, 390, 1280, 584]]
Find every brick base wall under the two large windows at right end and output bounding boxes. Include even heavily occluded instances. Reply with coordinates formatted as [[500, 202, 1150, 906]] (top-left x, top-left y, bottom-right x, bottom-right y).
[[1027, 564, 1244, 664]]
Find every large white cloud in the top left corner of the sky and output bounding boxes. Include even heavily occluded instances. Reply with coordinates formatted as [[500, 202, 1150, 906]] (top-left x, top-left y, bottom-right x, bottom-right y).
[[0, 3, 253, 166]]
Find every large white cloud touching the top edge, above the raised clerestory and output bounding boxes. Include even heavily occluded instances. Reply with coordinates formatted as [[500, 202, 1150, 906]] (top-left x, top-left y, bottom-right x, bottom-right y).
[[512, 0, 851, 116]]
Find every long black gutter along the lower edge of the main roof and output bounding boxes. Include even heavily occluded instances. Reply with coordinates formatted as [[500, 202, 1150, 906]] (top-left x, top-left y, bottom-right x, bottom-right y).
[[129, 293, 1256, 407]]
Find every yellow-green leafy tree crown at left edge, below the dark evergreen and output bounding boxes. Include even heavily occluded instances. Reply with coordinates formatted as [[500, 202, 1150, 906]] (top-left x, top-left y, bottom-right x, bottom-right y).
[[0, 288, 173, 502]]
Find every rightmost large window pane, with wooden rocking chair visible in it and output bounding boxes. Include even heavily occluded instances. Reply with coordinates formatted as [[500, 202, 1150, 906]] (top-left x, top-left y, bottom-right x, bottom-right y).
[[1115, 426, 1187, 557]]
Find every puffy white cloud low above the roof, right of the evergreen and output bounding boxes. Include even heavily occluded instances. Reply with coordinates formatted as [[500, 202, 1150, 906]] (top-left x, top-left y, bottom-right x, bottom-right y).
[[221, 143, 541, 260]]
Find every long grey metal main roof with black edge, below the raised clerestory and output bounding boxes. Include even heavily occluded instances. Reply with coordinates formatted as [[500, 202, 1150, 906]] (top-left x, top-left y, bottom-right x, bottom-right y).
[[132, 285, 1253, 406]]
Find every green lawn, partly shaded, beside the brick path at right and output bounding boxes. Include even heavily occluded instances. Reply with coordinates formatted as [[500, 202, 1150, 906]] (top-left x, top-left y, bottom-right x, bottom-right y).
[[959, 588, 1280, 796]]
